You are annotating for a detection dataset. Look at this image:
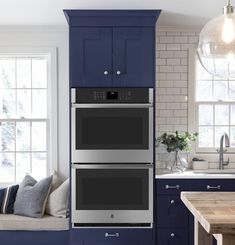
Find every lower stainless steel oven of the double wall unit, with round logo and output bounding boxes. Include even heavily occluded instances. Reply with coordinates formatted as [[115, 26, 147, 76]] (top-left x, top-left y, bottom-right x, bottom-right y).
[[72, 164, 153, 227]]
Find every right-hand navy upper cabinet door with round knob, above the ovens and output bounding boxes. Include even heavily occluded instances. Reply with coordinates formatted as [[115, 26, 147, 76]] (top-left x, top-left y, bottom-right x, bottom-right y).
[[113, 27, 155, 87]]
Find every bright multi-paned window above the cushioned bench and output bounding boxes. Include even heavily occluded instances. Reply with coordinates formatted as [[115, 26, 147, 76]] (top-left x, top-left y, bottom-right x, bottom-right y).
[[0, 47, 57, 183]]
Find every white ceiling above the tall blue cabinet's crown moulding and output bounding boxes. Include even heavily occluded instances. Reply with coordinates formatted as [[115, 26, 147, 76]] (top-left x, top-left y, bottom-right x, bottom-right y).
[[0, 0, 231, 27]]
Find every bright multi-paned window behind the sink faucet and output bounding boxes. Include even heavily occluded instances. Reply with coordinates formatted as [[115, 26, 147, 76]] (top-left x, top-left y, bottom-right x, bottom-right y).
[[189, 48, 235, 153]]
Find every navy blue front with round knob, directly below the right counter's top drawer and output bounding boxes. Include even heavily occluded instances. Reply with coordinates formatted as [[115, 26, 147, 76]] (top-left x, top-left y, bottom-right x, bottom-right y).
[[156, 195, 188, 228]]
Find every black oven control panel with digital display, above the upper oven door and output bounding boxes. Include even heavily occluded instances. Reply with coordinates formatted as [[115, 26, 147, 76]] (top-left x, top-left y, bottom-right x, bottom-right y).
[[71, 88, 153, 104]]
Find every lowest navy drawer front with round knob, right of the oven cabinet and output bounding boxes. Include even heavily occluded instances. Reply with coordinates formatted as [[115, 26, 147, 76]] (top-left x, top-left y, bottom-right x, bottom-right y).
[[156, 228, 188, 245]]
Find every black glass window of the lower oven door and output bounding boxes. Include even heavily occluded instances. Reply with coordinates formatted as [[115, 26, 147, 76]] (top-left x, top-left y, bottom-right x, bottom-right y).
[[75, 169, 149, 210]]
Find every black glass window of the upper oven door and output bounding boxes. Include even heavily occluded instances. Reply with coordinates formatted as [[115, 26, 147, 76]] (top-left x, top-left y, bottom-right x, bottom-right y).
[[75, 108, 149, 149]]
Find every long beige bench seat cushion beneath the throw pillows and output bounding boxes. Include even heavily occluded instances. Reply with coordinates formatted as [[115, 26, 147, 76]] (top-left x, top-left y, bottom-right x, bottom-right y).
[[0, 214, 69, 231]]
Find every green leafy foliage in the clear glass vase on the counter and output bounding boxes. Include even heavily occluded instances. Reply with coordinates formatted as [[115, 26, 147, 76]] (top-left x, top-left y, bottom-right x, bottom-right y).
[[157, 131, 198, 152]]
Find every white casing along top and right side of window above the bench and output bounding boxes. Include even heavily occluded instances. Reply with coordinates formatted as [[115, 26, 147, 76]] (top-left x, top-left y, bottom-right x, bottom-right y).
[[0, 46, 58, 186]]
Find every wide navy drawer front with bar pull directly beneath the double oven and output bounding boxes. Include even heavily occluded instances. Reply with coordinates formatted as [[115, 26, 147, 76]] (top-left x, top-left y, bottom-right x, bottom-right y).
[[70, 228, 154, 245]]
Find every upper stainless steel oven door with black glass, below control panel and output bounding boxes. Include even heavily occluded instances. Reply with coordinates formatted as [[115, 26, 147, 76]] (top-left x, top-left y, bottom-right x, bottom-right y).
[[71, 104, 153, 163]]
